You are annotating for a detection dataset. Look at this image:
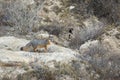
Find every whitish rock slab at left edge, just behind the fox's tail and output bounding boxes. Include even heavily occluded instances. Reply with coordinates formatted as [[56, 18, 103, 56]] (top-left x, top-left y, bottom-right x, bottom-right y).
[[0, 36, 29, 51]]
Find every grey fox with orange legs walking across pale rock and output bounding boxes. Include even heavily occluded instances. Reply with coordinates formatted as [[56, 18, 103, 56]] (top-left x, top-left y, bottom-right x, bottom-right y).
[[20, 39, 50, 52]]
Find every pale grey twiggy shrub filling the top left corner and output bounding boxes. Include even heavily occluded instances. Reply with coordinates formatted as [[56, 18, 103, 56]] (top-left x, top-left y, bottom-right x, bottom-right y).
[[0, 0, 44, 34]]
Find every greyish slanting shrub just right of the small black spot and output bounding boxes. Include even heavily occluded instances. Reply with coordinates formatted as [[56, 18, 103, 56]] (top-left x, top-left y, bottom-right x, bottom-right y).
[[69, 19, 104, 49]]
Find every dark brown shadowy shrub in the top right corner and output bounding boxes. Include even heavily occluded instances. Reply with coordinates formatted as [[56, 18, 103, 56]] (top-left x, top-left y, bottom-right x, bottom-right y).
[[88, 0, 120, 24]]
